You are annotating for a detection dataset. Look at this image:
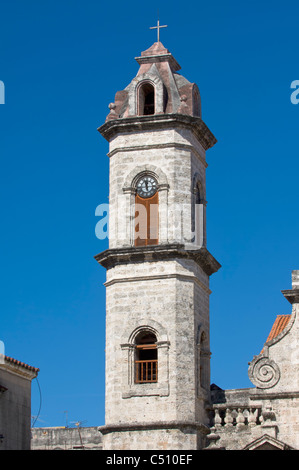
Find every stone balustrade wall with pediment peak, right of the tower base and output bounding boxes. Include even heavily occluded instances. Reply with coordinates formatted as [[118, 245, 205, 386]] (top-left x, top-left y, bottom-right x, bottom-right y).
[[207, 388, 299, 450]]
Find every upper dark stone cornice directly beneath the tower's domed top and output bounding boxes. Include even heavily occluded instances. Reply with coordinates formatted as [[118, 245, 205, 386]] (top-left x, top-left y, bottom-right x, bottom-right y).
[[98, 114, 217, 150]]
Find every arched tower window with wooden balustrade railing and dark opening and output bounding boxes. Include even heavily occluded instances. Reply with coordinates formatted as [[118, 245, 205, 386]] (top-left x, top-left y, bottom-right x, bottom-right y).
[[135, 331, 158, 383]]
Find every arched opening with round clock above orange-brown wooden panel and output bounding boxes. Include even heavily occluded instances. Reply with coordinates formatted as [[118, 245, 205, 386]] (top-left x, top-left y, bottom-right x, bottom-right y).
[[134, 174, 159, 246]]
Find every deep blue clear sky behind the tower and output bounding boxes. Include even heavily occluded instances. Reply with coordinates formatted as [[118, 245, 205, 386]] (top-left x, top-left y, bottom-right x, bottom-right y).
[[0, 0, 299, 426]]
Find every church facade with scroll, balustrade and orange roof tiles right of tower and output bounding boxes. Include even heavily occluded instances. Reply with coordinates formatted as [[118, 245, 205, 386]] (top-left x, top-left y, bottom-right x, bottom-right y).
[[207, 271, 299, 450]]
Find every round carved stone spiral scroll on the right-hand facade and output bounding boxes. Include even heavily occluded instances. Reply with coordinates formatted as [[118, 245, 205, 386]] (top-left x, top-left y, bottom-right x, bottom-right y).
[[248, 355, 280, 389]]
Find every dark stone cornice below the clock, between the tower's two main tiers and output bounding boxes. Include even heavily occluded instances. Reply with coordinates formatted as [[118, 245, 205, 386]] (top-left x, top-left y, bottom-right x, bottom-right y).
[[95, 244, 221, 276]]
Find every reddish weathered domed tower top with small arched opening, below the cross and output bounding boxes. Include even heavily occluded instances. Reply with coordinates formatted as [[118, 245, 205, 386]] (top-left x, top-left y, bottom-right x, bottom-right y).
[[106, 42, 201, 122]]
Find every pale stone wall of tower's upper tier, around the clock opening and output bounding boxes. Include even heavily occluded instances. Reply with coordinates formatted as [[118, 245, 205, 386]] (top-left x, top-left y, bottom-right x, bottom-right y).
[[109, 125, 206, 252]]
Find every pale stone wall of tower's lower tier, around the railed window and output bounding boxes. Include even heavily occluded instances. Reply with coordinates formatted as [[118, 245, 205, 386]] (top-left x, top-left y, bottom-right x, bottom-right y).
[[106, 260, 210, 432]]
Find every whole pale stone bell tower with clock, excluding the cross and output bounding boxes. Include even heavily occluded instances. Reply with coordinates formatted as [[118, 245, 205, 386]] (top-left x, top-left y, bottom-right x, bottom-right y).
[[95, 41, 220, 450]]
